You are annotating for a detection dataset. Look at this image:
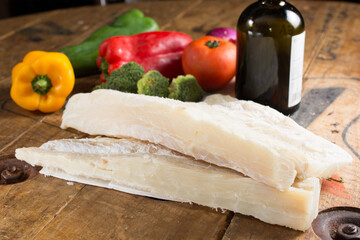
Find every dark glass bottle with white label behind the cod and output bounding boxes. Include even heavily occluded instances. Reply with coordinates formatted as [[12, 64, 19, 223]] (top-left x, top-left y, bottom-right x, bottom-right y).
[[235, 0, 305, 114]]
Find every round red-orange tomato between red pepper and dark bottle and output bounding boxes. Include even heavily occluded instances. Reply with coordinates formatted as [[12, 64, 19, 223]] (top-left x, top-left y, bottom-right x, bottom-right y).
[[182, 36, 236, 91]]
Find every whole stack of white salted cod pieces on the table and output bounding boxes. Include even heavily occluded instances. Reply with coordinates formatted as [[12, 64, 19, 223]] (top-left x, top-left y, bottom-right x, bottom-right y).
[[16, 90, 352, 231]]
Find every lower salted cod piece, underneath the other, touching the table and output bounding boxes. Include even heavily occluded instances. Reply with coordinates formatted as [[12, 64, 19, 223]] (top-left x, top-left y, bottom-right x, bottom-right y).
[[15, 138, 320, 231]]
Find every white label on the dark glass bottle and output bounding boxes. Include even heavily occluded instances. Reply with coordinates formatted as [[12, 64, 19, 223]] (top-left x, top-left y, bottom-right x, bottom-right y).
[[288, 31, 305, 107]]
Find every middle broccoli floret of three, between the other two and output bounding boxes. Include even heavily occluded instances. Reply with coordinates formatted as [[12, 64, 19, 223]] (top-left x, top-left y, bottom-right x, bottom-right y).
[[137, 70, 169, 97]]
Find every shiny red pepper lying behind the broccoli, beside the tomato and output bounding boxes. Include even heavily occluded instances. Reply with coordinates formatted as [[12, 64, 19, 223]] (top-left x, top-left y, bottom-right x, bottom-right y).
[[97, 31, 192, 81]]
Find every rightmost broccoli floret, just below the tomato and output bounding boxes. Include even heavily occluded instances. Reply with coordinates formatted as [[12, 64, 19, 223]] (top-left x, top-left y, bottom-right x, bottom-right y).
[[169, 74, 203, 102]]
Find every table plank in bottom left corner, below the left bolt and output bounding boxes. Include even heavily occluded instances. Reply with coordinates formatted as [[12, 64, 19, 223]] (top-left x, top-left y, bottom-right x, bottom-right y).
[[0, 174, 83, 239]]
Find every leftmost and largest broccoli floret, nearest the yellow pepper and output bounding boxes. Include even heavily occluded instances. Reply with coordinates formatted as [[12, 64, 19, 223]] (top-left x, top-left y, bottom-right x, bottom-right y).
[[94, 62, 145, 93]]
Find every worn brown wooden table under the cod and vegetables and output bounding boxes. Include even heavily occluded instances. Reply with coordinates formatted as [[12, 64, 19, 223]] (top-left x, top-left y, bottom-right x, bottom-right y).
[[0, 0, 360, 239]]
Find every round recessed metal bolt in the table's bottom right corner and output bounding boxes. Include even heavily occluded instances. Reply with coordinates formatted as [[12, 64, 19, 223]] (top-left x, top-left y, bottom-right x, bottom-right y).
[[312, 207, 360, 240]]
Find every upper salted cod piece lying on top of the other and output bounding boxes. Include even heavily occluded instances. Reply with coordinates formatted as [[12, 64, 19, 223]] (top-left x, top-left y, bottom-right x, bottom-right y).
[[61, 90, 352, 190]]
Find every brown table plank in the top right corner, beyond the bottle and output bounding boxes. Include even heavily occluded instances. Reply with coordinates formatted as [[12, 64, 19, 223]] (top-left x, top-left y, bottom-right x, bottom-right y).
[[307, 3, 360, 79]]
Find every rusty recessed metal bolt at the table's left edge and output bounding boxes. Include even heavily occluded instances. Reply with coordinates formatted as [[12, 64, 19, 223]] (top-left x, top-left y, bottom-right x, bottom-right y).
[[0, 156, 41, 185]]
